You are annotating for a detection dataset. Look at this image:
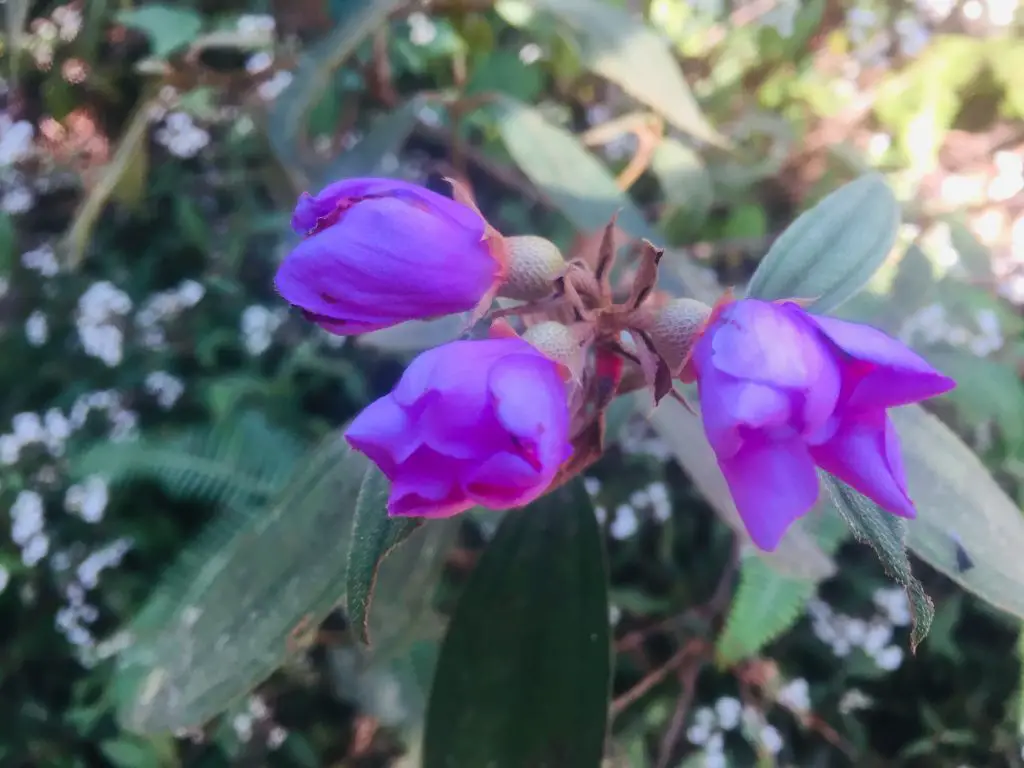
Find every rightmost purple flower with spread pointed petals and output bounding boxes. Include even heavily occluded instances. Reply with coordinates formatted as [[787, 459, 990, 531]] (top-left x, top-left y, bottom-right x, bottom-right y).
[[692, 299, 955, 550]]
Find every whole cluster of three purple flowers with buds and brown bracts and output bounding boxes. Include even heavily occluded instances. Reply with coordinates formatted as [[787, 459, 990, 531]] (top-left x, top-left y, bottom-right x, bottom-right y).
[[275, 178, 954, 550]]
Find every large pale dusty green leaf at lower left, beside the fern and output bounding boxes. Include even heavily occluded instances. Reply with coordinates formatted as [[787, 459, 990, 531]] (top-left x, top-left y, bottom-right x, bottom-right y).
[[114, 434, 368, 732]]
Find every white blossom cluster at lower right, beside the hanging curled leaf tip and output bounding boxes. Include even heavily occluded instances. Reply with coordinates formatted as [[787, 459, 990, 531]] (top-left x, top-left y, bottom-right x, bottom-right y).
[[807, 590, 910, 672]]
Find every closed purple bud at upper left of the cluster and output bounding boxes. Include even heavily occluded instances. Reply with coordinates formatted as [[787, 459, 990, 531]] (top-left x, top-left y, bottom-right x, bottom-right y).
[[275, 178, 503, 336]]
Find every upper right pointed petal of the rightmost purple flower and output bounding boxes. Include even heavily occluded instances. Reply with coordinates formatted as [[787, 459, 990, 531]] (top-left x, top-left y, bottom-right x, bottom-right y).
[[807, 314, 956, 409]]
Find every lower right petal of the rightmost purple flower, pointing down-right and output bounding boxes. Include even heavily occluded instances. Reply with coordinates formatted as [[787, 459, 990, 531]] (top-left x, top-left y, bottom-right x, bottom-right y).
[[811, 409, 916, 518]]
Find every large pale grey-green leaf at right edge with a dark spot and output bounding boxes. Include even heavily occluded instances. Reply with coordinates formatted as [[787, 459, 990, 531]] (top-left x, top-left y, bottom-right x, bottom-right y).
[[890, 406, 1024, 618]]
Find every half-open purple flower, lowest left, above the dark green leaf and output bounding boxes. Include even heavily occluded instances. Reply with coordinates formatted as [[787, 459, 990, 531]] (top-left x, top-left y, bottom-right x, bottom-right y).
[[345, 337, 572, 517]]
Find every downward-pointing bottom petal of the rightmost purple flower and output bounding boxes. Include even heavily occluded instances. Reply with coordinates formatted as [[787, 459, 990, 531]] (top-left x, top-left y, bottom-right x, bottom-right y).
[[719, 438, 820, 552]]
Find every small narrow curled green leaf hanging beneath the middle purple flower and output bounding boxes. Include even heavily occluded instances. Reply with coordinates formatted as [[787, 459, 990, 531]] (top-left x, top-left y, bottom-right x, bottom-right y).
[[346, 467, 423, 645]]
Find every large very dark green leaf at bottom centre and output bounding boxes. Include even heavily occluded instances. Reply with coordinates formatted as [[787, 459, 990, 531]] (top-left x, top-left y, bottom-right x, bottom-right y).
[[423, 481, 611, 768]]
